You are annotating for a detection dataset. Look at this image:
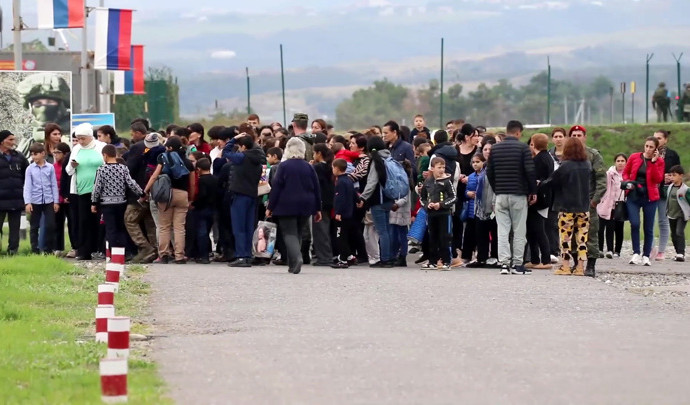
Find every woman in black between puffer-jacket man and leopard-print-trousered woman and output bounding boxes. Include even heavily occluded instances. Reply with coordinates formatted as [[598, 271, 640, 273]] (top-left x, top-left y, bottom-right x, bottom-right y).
[[525, 133, 553, 270]]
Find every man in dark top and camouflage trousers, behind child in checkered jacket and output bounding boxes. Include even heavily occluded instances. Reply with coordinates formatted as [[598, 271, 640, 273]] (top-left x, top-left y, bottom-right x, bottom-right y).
[[122, 122, 160, 263]]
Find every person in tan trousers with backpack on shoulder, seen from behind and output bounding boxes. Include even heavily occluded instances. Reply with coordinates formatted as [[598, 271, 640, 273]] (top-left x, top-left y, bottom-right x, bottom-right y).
[[144, 135, 196, 264]]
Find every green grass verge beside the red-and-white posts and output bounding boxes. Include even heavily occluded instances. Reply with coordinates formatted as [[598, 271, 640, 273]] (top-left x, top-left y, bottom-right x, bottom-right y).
[[0, 256, 171, 404]]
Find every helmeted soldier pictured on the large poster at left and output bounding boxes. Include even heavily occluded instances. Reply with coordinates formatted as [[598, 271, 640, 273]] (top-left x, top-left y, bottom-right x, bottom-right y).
[[17, 72, 71, 155]]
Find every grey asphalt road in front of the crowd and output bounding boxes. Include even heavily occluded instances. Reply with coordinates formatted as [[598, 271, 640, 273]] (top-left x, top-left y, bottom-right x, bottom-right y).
[[147, 259, 690, 404]]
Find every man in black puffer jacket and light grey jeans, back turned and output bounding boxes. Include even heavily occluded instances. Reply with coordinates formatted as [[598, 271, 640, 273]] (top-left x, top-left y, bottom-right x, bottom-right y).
[[486, 121, 537, 274]]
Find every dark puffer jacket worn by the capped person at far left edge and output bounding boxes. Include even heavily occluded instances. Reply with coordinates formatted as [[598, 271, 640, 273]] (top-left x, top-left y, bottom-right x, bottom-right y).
[[0, 150, 29, 210]]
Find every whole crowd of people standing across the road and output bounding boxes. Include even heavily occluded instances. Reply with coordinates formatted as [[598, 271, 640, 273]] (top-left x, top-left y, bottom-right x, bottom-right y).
[[0, 113, 690, 277]]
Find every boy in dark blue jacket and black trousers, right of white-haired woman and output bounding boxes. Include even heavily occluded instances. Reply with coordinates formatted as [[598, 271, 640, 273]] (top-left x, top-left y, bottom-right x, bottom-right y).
[[331, 159, 358, 269]]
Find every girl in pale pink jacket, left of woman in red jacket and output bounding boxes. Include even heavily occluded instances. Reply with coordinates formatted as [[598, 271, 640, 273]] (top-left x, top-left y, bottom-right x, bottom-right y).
[[597, 153, 628, 259]]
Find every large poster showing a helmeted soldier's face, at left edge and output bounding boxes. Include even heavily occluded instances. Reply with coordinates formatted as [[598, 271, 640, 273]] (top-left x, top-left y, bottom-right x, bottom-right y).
[[0, 71, 72, 155]]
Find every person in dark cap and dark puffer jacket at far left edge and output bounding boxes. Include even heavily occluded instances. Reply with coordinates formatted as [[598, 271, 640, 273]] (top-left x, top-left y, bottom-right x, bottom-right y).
[[0, 130, 29, 255]]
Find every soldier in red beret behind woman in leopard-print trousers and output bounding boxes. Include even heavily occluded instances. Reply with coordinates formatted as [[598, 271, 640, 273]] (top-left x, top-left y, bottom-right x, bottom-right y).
[[568, 125, 606, 277]]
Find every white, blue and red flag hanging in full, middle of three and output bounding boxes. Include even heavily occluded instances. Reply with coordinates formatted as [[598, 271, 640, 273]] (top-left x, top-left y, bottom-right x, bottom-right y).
[[94, 8, 132, 70]]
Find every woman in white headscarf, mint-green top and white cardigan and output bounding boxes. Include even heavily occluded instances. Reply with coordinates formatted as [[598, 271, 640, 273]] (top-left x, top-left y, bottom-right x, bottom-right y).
[[66, 123, 106, 260]]
